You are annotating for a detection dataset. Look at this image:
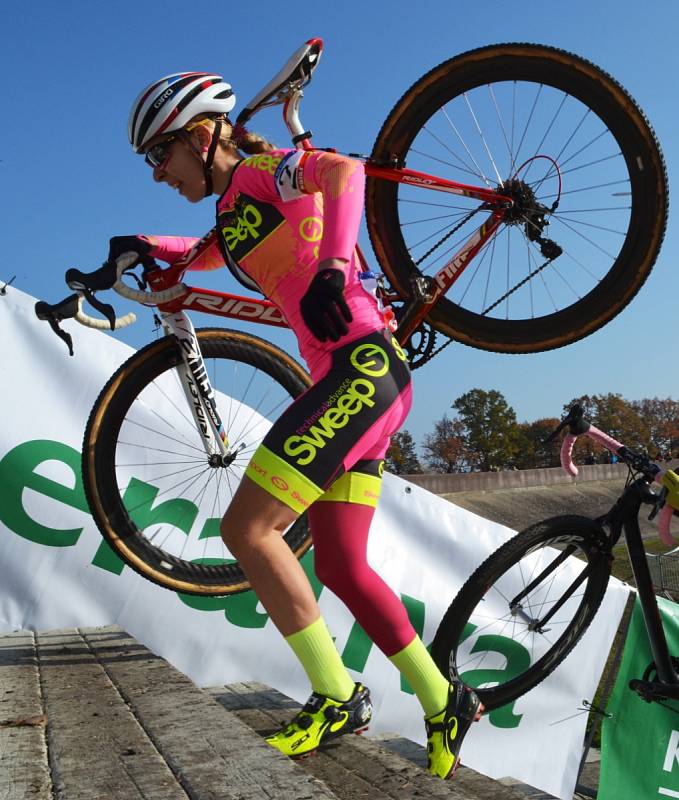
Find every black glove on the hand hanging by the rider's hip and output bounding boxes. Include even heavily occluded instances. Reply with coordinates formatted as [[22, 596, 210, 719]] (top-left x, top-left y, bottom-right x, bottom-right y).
[[299, 269, 353, 342]]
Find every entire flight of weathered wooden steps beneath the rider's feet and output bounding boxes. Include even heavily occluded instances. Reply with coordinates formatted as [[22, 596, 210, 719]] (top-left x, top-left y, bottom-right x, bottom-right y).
[[0, 627, 584, 800]]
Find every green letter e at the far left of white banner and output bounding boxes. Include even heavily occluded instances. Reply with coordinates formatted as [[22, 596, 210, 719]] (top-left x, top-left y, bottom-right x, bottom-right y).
[[0, 439, 89, 547]]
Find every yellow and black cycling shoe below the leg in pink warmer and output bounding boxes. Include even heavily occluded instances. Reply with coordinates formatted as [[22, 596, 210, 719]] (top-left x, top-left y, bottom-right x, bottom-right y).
[[424, 679, 483, 779]]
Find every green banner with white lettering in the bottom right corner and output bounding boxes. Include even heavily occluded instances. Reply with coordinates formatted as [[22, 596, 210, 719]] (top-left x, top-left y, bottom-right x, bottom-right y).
[[597, 596, 679, 800]]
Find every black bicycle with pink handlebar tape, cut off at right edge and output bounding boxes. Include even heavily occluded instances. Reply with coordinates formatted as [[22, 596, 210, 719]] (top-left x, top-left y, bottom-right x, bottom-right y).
[[432, 405, 679, 709]]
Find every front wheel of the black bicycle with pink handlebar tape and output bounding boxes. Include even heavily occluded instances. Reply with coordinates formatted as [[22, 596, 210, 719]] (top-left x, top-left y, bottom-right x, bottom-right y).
[[432, 516, 612, 710]]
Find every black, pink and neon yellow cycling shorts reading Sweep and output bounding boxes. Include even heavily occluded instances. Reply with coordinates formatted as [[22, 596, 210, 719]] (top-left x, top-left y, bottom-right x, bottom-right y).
[[245, 331, 412, 514]]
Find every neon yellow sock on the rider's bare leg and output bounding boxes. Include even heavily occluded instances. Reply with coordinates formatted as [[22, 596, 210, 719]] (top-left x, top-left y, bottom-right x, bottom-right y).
[[285, 617, 354, 701]]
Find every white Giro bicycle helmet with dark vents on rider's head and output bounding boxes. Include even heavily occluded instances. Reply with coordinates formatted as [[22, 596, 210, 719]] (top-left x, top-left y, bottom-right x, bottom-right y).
[[128, 72, 236, 153]]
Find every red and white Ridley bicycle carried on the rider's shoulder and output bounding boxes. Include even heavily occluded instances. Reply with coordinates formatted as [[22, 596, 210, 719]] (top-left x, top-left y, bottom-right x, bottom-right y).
[[36, 39, 667, 595]]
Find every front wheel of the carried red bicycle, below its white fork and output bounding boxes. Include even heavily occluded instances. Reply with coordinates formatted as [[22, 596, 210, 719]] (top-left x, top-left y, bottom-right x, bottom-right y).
[[82, 329, 311, 595]]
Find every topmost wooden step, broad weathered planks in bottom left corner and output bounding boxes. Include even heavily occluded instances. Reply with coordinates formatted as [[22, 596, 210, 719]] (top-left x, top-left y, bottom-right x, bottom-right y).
[[0, 627, 335, 800]]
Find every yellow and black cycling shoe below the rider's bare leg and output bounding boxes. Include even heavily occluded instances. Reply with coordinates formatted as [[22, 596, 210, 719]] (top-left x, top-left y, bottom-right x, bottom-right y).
[[266, 683, 372, 758]]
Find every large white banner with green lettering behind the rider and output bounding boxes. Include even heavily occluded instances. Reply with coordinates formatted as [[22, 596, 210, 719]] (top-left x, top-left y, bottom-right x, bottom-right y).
[[0, 288, 628, 800]]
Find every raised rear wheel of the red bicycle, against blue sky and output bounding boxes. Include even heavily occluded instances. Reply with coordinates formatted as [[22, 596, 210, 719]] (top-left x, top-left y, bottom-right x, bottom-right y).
[[366, 44, 668, 353]]
